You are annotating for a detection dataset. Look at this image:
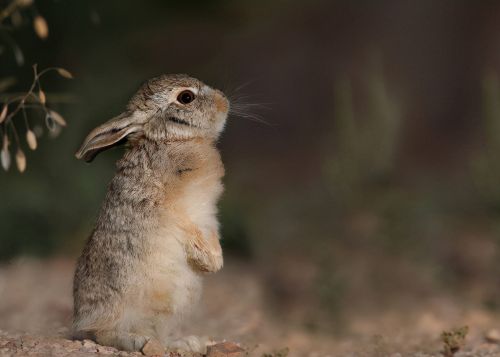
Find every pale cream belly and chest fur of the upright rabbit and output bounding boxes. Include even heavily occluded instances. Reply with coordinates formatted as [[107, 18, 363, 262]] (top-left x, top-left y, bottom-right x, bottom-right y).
[[121, 161, 222, 338]]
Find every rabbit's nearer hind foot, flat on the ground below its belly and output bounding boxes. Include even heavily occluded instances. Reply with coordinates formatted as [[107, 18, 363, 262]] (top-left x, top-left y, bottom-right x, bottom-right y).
[[95, 330, 165, 355]]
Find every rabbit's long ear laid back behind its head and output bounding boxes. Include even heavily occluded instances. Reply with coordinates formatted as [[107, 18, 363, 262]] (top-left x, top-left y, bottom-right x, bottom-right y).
[[75, 113, 143, 162]]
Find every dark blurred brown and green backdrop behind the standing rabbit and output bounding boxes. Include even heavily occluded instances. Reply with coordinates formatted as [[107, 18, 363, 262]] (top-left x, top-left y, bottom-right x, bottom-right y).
[[0, 0, 500, 354]]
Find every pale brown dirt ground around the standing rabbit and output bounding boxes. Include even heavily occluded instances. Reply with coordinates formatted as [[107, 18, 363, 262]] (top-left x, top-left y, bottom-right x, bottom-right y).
[[0, 259, 500, 357]]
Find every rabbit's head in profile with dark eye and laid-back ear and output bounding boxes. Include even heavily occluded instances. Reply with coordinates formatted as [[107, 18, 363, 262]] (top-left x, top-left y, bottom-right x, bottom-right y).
[[76, 74, 229, 162]]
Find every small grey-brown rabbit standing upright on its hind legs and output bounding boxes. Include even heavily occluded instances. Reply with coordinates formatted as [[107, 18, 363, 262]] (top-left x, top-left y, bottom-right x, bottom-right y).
[[73, 75, 229, 354]]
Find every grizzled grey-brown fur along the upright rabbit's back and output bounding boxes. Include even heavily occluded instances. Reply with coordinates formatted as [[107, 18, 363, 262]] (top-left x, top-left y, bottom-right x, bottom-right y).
[[73, 148, 159, 330]]
